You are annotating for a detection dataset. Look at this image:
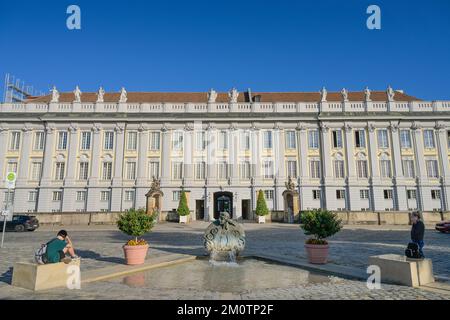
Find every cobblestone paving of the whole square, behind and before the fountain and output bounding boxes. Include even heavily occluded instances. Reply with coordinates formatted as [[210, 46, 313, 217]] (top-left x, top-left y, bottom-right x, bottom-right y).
[[0, 222, 450, 299]]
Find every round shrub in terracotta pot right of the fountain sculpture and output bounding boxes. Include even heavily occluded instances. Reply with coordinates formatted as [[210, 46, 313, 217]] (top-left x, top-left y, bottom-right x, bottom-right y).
[[301, 209, 342, 264]]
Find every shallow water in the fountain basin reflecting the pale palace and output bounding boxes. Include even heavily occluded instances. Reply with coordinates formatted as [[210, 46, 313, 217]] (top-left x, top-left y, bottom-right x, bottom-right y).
[[109, 259, 330, 293]]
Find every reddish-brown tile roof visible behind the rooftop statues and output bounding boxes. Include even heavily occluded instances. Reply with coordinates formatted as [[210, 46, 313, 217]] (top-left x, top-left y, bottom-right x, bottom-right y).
[[27, 91, 422, 103]]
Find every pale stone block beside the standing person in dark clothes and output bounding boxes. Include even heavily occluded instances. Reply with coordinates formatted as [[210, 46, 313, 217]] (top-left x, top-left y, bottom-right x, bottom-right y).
[[369, 254, 434, 287]]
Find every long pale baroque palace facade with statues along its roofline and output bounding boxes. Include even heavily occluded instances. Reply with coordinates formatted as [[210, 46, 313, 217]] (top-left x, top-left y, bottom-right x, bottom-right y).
[[0, 87, 450, 220]]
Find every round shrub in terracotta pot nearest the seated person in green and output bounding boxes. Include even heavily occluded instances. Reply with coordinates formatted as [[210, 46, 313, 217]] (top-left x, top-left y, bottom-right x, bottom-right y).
[[117, 209, 155, 265]]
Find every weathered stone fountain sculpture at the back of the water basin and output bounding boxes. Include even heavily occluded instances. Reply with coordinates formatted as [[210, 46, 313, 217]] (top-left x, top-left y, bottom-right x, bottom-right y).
[[203, 212, 245, 262]]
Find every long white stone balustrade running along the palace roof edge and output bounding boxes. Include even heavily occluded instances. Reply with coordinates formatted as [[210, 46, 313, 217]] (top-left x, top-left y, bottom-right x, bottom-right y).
[[0, 101, 450, 114]]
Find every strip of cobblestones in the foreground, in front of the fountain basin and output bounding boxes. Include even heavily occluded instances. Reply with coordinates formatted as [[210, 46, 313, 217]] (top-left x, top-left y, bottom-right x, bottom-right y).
[[0, 278, 450, 300]]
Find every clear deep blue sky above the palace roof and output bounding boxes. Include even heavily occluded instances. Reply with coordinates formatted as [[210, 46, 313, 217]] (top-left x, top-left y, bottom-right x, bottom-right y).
[[0, 0, 450, 100]]
